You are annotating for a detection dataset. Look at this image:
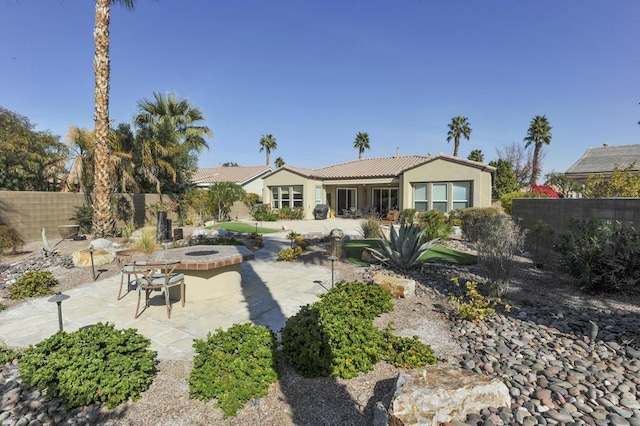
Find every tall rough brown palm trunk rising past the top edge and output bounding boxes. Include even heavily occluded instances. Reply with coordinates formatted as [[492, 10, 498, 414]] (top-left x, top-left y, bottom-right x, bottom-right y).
[[93, 0, 114, 237]]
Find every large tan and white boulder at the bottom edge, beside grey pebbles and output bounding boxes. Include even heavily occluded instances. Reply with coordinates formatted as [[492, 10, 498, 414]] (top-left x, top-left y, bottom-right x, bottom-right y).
[[389, 364, 511, 426]]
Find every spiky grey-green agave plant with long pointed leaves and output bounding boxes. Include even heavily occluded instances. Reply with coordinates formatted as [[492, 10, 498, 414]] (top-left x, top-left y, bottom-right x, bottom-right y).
[[368, 223, 438, 271]]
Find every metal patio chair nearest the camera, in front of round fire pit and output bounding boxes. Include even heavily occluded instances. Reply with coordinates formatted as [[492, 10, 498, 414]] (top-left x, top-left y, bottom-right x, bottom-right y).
[[132, 261, 185, 319]]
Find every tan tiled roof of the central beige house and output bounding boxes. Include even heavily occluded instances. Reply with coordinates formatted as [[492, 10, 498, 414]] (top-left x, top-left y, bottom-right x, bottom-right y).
[[264, 154, 495, 180]]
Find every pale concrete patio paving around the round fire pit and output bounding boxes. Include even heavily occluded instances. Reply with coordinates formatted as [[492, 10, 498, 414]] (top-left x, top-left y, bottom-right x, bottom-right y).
[[0, 219, 360, 359]]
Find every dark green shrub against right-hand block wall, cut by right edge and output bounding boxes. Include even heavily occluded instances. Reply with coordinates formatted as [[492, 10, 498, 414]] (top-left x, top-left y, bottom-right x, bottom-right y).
[[556, 218, 640, 292]]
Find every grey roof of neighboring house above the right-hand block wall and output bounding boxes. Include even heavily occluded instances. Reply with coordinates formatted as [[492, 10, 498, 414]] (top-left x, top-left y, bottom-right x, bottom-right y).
[[565, 145, 640, 176]]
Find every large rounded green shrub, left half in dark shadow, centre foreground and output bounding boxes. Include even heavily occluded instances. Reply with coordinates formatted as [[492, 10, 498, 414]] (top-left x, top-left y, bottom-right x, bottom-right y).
[[281, 281, 393, 379]]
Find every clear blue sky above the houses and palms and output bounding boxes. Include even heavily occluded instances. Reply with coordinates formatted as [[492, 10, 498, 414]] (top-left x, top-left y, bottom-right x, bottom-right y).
[[0, 0, 640, 177]]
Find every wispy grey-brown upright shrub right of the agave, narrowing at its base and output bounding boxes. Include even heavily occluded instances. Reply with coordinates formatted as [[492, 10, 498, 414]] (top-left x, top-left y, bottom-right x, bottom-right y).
[[477, 216, 526, 296]]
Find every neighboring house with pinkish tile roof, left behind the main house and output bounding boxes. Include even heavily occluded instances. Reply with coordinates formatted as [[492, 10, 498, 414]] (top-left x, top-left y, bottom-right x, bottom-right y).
[[191, 166, 272, 196]]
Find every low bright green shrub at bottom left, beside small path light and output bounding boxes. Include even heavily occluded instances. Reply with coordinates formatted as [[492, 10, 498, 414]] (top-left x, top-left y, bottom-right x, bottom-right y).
[[20, 323, 155, 408]]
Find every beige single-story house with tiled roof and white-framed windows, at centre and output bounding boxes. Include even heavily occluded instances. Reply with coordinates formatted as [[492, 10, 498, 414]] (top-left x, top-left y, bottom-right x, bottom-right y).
[[263, 154, 495, 219]]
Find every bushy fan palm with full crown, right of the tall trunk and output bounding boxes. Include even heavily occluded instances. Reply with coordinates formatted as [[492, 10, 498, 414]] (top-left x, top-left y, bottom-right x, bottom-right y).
[[133, 92, 213, 194]]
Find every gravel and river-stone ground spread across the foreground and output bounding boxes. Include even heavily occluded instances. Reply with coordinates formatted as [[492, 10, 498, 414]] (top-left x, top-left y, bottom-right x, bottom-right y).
[[0, 241, 640, 426]]
